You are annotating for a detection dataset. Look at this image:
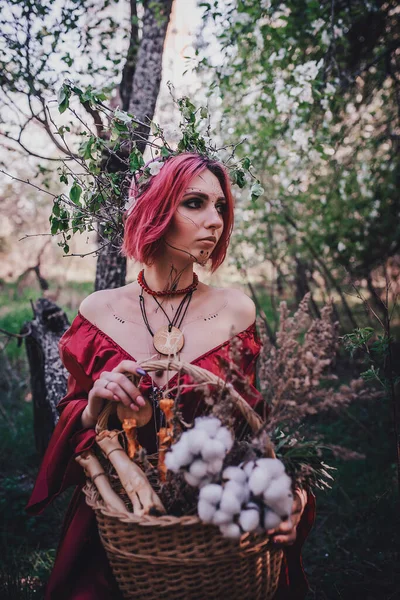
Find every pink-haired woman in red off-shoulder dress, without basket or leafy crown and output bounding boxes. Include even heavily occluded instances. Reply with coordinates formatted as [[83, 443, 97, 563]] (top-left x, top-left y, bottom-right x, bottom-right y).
[[28, 153, 314, 600]]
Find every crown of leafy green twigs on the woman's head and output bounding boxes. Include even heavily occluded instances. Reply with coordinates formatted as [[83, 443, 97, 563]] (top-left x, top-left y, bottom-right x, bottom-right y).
[[42, 81, 263, 254]]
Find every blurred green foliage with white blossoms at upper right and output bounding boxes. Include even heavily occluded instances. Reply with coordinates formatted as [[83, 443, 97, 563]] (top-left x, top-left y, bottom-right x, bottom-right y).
[[197, 0, 400, 277]]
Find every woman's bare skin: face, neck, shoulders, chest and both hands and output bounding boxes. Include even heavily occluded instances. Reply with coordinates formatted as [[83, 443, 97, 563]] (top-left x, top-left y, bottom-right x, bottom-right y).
[[80, 170, 304, 544]]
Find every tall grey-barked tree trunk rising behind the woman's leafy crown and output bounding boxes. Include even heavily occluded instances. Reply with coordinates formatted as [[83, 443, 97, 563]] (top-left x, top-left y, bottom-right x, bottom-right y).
[[95, 0, 173, 290]]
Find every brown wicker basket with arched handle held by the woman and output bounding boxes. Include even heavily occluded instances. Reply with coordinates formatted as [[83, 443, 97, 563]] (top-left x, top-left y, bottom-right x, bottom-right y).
[[84, 360, 282, 600]]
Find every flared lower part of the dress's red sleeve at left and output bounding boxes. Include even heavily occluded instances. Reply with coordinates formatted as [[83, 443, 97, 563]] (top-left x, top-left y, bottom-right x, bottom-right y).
[[27, 366, 95, 514]]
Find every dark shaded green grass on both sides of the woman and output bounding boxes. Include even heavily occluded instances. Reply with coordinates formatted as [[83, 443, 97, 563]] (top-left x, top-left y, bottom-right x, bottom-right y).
[[0, 284, 400, 600]]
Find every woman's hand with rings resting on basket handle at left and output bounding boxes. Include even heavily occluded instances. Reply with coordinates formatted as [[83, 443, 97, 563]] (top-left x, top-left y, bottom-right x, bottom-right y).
[[82, 360, 146, 427]]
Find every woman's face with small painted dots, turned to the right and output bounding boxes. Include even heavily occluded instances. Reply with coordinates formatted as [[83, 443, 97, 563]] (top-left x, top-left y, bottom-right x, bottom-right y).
[[164, 169, 227, 263]]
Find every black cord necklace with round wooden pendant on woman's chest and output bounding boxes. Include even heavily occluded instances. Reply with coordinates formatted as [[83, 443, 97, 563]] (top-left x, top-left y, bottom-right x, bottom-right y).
[[139, 290, 194, 356]]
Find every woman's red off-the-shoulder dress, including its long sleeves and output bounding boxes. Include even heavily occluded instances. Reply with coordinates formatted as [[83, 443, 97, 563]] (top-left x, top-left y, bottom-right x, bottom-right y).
[[27, 314, 315, 600]]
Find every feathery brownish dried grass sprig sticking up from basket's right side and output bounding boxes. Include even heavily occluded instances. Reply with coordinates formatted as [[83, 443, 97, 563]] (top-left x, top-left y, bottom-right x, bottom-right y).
[[259, 294, 373, 430]]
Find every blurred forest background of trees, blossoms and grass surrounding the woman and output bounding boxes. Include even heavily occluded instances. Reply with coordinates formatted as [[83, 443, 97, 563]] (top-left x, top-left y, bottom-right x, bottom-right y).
[[0, 0, 400, 600]]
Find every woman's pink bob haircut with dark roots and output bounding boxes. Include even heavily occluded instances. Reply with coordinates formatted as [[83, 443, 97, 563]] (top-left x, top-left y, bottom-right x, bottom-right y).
[[122, 152, 234, 271]]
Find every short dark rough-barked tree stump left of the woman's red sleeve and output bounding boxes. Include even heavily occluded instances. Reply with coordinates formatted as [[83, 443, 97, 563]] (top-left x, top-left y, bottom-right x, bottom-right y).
[[22, 298, 69, 456]]
